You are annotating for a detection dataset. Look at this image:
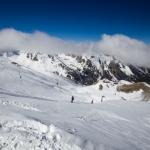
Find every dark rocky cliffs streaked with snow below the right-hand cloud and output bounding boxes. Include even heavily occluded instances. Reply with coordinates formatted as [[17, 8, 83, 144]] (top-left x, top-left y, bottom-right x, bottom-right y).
[[65, 58, 150, 85]]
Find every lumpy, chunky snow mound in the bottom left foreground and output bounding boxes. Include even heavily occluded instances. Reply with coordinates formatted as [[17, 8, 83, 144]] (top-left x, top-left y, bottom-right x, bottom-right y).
[[0, 120, 80, 150]]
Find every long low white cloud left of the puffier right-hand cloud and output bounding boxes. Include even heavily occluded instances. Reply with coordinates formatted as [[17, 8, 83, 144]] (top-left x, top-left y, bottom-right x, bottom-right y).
[[0, 29, 90, 53]]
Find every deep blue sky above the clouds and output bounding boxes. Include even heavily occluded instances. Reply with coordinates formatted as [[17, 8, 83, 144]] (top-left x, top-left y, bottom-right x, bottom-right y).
[[0, 0, 150, 43]]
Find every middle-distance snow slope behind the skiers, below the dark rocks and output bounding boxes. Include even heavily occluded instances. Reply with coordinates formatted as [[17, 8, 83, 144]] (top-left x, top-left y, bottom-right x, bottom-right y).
[[0, 51, 143, 103]]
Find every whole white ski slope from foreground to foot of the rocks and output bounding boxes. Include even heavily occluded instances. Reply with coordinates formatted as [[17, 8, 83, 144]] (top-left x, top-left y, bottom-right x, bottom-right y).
[[0, 51, 150, 150]]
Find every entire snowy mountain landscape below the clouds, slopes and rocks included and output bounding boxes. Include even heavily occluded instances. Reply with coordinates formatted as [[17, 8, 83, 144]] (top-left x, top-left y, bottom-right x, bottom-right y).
[[0, 51, 150, 150]]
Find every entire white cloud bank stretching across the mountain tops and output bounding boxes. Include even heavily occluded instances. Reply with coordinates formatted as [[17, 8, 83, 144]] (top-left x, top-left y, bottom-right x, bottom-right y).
[[0, 29, 150, 67]]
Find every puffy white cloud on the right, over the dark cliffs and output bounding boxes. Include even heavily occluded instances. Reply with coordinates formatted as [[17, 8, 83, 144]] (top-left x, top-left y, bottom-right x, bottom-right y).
[[94, 34, 150, 67]]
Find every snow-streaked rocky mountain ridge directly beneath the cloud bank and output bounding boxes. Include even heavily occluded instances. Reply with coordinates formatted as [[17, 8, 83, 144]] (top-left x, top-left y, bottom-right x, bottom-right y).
[[3, 51, 150, 85]]
